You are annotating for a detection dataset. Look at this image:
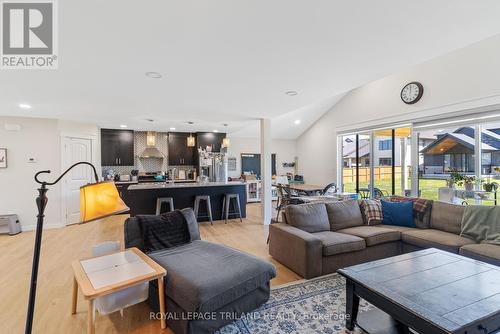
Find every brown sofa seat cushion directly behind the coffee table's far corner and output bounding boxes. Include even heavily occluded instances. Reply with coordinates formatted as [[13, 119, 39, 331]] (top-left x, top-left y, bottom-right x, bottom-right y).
[[401, 229, 474, 254]]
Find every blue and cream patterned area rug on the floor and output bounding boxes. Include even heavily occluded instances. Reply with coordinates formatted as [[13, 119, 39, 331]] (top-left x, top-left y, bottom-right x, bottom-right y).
[[216, 274, 373, 334]]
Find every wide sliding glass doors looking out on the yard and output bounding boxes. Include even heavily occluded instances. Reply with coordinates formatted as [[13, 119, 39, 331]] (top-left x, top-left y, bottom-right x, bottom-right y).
[[339, 112, 500, 205]]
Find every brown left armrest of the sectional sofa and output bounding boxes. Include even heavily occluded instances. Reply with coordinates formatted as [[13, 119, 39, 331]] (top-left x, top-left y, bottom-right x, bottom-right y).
[[269, 223, 323, 278]]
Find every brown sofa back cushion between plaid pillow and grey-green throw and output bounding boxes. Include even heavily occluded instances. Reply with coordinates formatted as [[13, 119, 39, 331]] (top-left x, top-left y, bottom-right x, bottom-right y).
[[431, 201, 465, 234]]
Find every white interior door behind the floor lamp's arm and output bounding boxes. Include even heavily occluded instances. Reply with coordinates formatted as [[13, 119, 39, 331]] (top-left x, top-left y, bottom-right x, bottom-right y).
[[62, 137, 93, 225]]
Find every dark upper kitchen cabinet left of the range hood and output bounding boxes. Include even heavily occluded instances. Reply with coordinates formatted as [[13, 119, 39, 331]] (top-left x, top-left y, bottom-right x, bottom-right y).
[[101, 129, 134, 166]]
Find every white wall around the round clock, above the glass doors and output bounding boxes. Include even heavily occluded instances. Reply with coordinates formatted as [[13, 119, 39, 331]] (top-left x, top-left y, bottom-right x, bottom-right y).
[[297, 35, 500, 184]]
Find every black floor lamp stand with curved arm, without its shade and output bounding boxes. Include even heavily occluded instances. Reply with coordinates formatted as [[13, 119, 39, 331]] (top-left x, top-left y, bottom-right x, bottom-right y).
[[24, 161, 99, 334]]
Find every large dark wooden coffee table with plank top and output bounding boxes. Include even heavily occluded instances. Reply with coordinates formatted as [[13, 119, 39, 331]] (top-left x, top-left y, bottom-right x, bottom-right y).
[[338, 248, 500, 334]]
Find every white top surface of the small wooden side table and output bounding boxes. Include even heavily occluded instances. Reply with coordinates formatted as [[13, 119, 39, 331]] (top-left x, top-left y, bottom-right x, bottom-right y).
[[80, 250, 155, 290]]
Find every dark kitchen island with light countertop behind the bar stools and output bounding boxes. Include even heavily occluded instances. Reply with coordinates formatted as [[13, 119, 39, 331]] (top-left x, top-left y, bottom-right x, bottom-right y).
[[122, 182, 247, 221]]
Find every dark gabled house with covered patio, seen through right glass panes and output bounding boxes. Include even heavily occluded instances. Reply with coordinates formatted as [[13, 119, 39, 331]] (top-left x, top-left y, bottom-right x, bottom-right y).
[[420, 127, 500, 175]]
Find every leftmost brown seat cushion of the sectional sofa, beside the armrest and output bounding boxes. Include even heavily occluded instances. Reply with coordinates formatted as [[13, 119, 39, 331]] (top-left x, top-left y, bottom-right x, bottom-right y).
[[312, 231, 366, 261]]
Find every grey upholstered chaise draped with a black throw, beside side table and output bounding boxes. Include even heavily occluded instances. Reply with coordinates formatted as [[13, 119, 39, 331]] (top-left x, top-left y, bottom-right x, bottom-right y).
[[125, 210, 276, 334]]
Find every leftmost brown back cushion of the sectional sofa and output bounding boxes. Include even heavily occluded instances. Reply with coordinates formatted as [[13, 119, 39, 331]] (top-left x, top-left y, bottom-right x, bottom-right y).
[[285, 203, 330, 233]]
